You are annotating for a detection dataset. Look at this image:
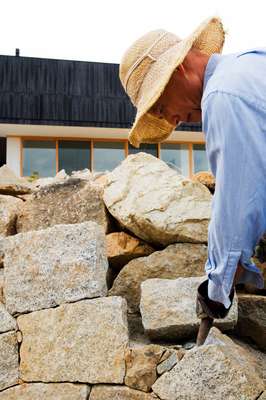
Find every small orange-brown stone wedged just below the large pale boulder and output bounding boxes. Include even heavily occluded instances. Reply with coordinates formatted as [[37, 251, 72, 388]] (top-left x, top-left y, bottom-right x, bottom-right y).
[[106, 232, 154, 270]]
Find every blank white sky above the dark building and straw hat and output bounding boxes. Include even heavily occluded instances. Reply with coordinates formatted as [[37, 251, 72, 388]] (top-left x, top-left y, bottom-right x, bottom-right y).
[[0, 0, 266, 63]]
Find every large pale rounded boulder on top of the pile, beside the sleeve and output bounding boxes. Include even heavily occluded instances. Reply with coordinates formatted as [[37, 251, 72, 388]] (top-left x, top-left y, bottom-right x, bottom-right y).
[[104, 153, 211, 245]]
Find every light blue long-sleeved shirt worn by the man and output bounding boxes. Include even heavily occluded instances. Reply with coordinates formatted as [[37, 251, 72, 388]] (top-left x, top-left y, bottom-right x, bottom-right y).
[[201, 48, 266, 308]]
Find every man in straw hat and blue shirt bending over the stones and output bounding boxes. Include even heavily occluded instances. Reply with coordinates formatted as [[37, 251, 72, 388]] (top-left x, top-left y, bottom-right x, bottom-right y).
[[120, 18, 266, 324]]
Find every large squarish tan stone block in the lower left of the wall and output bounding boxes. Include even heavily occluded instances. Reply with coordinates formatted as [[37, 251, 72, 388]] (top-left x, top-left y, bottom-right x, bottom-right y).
[[17, 297, 128, 383]]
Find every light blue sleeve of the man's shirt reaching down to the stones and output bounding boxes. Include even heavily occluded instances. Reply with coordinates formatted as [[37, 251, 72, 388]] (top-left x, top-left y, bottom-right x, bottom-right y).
[[202, 92, 266, 308]]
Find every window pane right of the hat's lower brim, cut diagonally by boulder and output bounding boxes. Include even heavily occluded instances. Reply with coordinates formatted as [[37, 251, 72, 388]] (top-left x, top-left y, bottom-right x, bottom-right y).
[[160, 143, 189, 176]]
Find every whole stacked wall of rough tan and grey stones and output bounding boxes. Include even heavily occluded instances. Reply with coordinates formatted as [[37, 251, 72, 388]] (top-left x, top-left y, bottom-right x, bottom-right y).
[[0, 158, 266, 400]]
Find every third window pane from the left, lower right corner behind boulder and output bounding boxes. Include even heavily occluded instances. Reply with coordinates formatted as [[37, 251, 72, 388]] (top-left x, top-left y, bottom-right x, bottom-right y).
[[93, 142, 125, 172]]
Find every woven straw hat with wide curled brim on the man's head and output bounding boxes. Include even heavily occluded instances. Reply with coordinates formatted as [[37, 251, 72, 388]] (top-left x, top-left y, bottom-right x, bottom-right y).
[[119, 17, 224, 147]]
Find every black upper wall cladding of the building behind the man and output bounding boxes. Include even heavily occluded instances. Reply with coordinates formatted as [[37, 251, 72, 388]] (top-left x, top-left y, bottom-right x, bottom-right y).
[[0, 56, 201, 130]]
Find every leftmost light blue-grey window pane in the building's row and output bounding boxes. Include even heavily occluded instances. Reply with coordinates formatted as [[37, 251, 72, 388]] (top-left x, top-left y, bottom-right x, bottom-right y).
[[23, 140, 56, 177]]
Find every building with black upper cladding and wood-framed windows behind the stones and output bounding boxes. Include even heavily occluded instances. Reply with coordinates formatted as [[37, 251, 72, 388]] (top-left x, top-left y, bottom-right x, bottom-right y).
[[0, 52, 208, 177]]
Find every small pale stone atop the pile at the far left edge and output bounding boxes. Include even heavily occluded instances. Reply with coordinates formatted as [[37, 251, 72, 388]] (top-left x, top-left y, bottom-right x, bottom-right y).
[[0, 165, 31, 196]]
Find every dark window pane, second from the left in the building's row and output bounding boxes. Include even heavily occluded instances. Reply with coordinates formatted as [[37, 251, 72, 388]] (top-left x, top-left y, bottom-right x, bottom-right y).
[[58, 140, 91, 174]]
